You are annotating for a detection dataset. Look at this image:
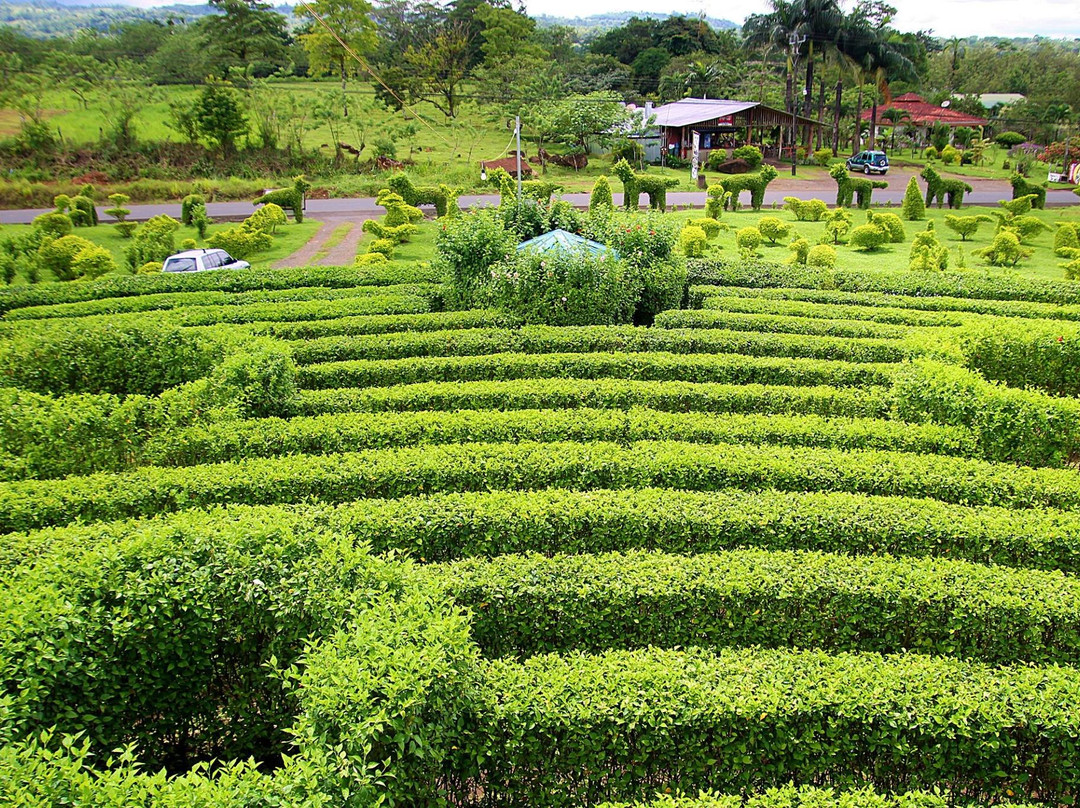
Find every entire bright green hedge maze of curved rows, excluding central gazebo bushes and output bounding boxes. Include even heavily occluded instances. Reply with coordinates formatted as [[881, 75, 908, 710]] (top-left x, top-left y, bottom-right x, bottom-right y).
[[0, 247, 1080, 808]]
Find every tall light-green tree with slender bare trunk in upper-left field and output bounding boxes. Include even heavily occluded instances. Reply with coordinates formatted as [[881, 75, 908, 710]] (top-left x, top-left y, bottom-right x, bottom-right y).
[[297, 0, 378, 118]]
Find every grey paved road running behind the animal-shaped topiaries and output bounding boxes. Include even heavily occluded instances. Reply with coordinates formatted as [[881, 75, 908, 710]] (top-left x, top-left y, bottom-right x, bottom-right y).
[[0, 176, 1080, 225]]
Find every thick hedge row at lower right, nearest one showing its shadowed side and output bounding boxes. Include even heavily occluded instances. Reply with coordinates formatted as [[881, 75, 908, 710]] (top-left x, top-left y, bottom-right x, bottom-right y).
[[462, 649, 1080, 806]]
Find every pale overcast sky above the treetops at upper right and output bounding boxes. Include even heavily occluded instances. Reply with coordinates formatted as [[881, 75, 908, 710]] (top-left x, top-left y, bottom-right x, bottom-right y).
[[526, 0, 1080, 38]]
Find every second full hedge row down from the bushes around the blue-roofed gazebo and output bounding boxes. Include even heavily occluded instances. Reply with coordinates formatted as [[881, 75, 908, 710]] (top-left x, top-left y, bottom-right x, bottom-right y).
[[297, 351, 897, 390]]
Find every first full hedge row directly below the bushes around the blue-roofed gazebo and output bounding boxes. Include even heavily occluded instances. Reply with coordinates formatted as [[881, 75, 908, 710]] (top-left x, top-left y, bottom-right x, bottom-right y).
[[293, 325, 910, 365]]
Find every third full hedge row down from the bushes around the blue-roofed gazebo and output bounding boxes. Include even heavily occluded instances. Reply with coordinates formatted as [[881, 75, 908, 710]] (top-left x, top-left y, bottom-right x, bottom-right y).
[[294, 378, 889, 417]]
